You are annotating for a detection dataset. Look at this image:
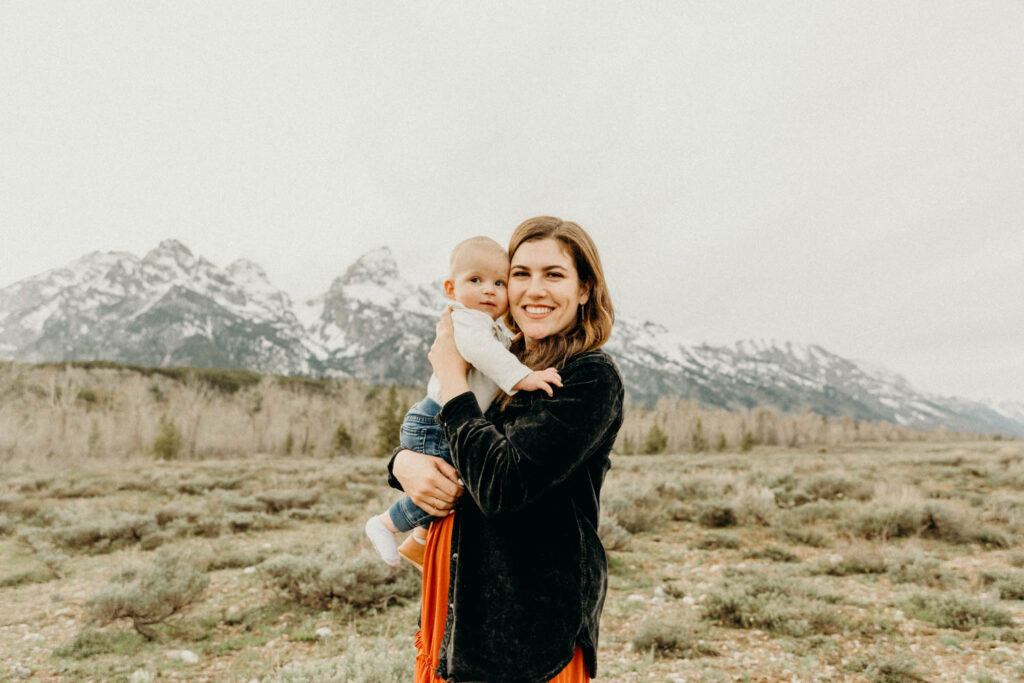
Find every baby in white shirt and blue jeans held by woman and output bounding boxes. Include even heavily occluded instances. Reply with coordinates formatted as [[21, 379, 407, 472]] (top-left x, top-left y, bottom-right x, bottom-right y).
[[366, 237, 561, 567]]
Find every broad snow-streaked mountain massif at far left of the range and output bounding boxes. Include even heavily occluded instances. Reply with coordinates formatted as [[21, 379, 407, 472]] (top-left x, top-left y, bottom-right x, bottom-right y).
[[0, 240, 313, 374]]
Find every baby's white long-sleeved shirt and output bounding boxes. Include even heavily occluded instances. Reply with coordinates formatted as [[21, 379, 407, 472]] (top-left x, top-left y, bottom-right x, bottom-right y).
[[427, 301, 534, 413]]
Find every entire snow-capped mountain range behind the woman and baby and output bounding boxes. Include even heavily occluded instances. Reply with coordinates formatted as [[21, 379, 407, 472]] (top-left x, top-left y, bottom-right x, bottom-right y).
[[0, 240, 1024, 435]]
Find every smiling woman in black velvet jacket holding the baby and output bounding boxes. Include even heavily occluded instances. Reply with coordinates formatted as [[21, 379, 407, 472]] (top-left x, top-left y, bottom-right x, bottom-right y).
[[388, 217, 623, 683]]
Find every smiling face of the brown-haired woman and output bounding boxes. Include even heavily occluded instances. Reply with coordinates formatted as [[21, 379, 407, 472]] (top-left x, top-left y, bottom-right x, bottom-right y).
[[508, 238, 590, 347]]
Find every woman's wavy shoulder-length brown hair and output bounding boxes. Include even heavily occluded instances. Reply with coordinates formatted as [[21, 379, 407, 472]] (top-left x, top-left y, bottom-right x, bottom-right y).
[[505, 216, 615, 370]]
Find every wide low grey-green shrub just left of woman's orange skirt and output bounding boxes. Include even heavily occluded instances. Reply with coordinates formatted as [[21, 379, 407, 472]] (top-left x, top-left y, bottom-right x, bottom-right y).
[[259, 550, 420, 611]]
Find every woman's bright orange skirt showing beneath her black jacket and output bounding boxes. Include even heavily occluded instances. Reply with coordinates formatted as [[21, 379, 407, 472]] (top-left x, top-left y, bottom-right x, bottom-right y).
[[414, 515, 590, 683]]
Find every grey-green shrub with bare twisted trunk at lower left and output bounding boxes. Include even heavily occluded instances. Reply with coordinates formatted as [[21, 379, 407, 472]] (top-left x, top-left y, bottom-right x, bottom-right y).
[[86, 553, 210, 639]]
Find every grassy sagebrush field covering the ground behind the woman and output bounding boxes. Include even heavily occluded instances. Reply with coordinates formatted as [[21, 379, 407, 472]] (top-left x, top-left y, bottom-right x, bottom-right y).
[[0, 441, 1024, 683]]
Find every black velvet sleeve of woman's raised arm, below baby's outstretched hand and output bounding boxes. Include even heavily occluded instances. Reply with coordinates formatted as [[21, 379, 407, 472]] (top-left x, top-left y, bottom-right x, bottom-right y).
[[439, 362, 623, 517]]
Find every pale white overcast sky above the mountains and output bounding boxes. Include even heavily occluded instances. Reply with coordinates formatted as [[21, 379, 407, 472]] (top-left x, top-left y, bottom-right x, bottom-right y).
[[0, 0, 1024, 400]]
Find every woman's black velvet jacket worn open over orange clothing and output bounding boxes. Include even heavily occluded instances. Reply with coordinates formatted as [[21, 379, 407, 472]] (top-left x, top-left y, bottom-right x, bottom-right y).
[[388, 351, 623, 683]]
